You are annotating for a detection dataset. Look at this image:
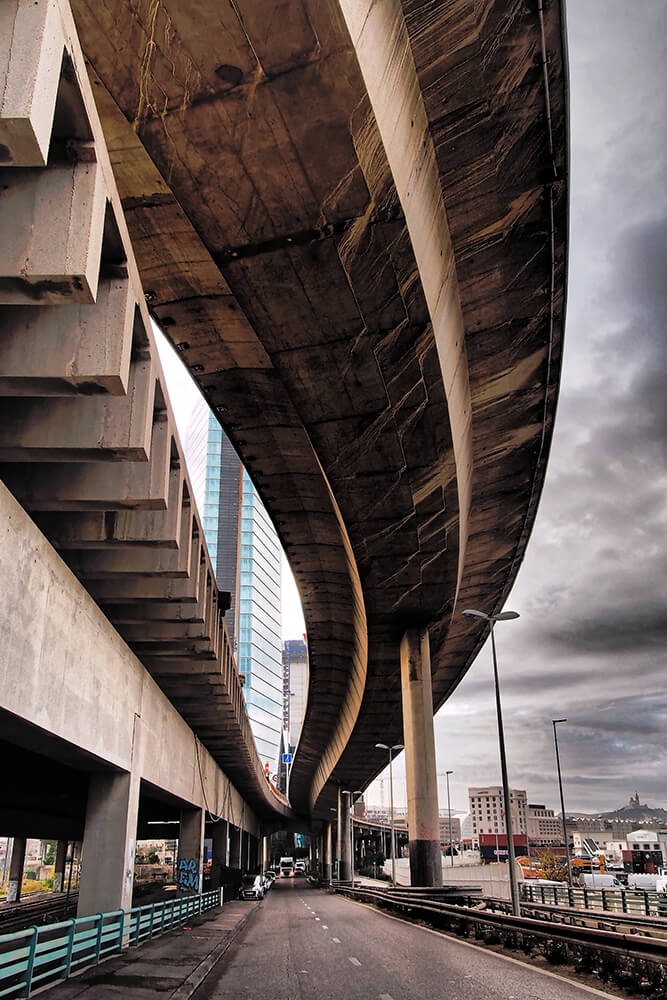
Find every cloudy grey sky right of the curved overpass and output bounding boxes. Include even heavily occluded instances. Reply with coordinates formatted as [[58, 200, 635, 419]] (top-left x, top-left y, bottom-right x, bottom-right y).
[[159, 0, 667, 811]]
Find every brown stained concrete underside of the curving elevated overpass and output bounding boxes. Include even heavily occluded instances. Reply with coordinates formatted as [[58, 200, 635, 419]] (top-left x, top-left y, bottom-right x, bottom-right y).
[[66, 0, 567, 818]]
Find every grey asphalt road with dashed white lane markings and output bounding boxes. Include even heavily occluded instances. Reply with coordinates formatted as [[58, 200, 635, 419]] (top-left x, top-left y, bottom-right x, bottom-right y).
[[196, 878, 609, 1000]]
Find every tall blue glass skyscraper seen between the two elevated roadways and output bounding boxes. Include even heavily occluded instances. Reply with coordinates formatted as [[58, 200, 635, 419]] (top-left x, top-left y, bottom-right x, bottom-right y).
[[184, 401, 283, 773]]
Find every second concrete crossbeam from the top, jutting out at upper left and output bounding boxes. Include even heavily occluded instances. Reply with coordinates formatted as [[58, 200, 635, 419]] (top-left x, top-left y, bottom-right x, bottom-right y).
[[0, 162, 107, 305]]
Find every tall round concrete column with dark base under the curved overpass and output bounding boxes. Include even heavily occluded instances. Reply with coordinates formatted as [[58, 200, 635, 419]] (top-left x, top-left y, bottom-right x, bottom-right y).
[[401, 628, 442, 886]]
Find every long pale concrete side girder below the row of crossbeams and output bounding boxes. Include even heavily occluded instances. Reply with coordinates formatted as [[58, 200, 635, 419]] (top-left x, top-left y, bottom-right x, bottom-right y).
[[0, 484, 259, 836]]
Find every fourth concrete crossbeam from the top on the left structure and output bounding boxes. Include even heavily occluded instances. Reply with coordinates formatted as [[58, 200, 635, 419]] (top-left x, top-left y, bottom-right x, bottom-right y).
[[0, 359, 155, 462]]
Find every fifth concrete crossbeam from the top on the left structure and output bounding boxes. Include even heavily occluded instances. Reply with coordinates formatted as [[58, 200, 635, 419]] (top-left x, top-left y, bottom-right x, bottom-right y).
[[4, 416, 172, 511]]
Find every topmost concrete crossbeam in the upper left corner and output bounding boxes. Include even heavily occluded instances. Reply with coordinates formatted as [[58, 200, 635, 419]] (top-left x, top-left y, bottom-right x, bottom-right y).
[[0, 0, 65, 167]]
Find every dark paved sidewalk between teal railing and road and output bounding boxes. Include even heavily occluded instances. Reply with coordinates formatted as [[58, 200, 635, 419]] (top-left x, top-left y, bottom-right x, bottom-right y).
[[40, 900, 259, 1000]]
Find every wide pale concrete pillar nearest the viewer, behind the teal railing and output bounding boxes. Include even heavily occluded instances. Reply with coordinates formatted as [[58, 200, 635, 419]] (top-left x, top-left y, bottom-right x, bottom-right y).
[[78, 773, 139, 917]]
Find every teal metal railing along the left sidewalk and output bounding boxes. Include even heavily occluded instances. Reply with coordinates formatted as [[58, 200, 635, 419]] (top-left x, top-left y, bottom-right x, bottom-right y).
[[0, 889, 222, 998]]
